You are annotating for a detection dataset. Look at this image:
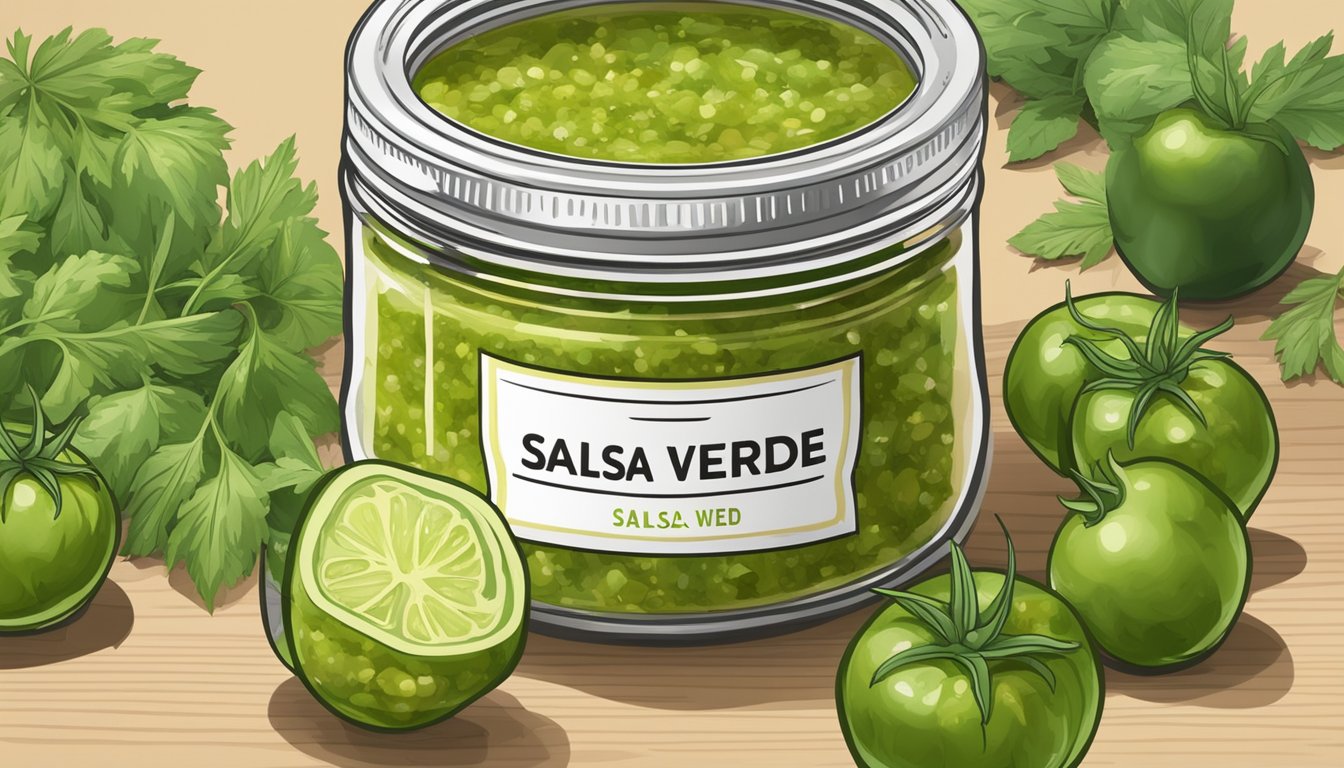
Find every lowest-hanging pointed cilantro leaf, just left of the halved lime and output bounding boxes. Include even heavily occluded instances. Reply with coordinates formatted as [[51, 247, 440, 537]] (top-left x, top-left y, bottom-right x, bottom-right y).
[[164, 445, 269, 611]]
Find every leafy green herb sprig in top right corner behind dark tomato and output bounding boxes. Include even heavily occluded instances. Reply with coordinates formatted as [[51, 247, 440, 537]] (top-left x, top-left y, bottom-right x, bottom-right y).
[[962, 0, 1344, 161]]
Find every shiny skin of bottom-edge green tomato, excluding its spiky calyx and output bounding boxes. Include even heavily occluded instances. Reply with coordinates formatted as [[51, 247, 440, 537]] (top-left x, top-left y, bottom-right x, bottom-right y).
[[836, 570, 1103, 768]]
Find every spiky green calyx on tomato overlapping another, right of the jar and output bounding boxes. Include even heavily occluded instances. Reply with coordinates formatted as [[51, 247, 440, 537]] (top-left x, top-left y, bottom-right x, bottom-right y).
[[1064, 284, 1232, 448]]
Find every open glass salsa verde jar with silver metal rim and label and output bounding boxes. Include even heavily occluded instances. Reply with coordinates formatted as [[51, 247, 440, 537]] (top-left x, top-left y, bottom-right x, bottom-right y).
[[343, 0, 989, 642]]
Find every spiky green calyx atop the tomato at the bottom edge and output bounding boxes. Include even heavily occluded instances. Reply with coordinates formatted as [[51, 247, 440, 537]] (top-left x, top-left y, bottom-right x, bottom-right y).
[[868, 515, 1081, 728]]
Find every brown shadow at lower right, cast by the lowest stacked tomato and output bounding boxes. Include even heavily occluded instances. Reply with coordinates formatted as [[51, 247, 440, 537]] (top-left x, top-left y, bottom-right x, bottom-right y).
[[1106, 613, 1293, 709]]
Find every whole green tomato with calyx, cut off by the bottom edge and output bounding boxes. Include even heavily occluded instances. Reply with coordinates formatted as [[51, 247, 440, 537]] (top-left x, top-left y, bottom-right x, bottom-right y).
[[836, 519, 1103, 768]]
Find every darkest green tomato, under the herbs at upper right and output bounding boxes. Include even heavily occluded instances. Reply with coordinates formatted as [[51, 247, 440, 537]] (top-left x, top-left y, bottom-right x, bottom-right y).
[[1106, 109, 1316, 301]]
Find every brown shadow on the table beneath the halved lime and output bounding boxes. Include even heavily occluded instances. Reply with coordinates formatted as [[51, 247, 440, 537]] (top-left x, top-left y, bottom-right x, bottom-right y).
[[267, 678, 570, 768]]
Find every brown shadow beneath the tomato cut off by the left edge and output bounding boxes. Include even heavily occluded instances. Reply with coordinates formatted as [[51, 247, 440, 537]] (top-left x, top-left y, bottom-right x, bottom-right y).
[[0, 580, 136, 670]]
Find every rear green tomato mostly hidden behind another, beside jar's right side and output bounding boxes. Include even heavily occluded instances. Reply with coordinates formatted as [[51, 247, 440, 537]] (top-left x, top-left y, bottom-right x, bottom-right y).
[[1004, 293, 1160, 475]]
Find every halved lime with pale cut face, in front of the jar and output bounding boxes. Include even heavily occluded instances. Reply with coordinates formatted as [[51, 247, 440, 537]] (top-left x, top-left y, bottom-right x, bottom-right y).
[[284, 461, 528, 730]]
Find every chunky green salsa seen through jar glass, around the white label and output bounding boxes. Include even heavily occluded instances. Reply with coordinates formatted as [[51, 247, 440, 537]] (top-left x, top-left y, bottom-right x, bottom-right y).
[[353, 226, 974, 613]]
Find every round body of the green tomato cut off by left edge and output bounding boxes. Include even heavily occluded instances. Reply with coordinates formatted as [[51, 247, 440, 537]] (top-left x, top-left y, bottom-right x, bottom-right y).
[[0, 441, 121, 635]]
